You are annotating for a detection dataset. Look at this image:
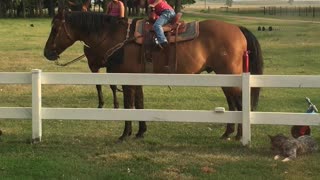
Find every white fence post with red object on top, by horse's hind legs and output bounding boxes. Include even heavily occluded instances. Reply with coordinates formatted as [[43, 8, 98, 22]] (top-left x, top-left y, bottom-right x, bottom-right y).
[[242, 73, 251, 146]]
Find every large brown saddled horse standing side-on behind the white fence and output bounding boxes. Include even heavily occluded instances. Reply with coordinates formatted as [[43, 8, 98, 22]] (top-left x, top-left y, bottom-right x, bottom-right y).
[[44, 8, 263, 140]]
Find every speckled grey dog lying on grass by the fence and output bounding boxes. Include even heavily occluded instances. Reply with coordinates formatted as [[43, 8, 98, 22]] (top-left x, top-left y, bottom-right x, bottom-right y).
[[268, 134, 318, 162]]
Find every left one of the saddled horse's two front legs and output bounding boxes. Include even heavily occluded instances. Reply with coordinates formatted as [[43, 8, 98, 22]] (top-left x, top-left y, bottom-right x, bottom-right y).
[[119, 86, 134, 141]]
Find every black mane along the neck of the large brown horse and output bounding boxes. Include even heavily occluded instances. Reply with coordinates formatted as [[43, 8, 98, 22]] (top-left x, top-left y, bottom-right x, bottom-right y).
[[65, 12, 127, 33]]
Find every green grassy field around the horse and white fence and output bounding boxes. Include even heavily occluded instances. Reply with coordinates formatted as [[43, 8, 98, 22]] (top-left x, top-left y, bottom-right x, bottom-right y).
[[0, 9, 320, 179]]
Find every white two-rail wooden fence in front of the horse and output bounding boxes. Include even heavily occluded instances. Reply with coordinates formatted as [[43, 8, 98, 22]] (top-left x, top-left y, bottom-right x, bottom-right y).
[[0, 69, 320, 145]]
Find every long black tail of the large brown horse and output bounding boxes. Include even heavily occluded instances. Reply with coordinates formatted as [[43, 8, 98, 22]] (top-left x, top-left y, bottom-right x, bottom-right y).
[[239, 26, 263, 110]]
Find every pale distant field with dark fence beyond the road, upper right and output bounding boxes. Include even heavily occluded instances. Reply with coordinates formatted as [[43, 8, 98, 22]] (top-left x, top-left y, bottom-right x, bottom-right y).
[[184, 0, 320, 21]]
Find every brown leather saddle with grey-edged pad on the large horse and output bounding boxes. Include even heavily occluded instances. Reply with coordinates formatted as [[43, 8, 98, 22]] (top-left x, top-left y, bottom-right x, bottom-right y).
[[134, 13, 199, 73]]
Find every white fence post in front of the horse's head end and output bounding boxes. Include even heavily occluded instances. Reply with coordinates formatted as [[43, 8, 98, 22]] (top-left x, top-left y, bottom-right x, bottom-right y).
[[32, 69, 42, 142]]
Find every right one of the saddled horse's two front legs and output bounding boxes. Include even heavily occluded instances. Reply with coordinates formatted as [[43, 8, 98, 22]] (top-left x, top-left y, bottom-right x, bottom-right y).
[[135, 86, 147, 138]]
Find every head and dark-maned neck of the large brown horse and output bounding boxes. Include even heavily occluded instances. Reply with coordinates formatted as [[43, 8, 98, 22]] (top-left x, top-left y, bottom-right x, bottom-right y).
[[44, 0, 128, 60]]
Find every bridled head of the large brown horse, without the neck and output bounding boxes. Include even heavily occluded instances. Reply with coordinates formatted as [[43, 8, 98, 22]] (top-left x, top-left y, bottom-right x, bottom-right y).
[[44, 2, 76, 61]]
